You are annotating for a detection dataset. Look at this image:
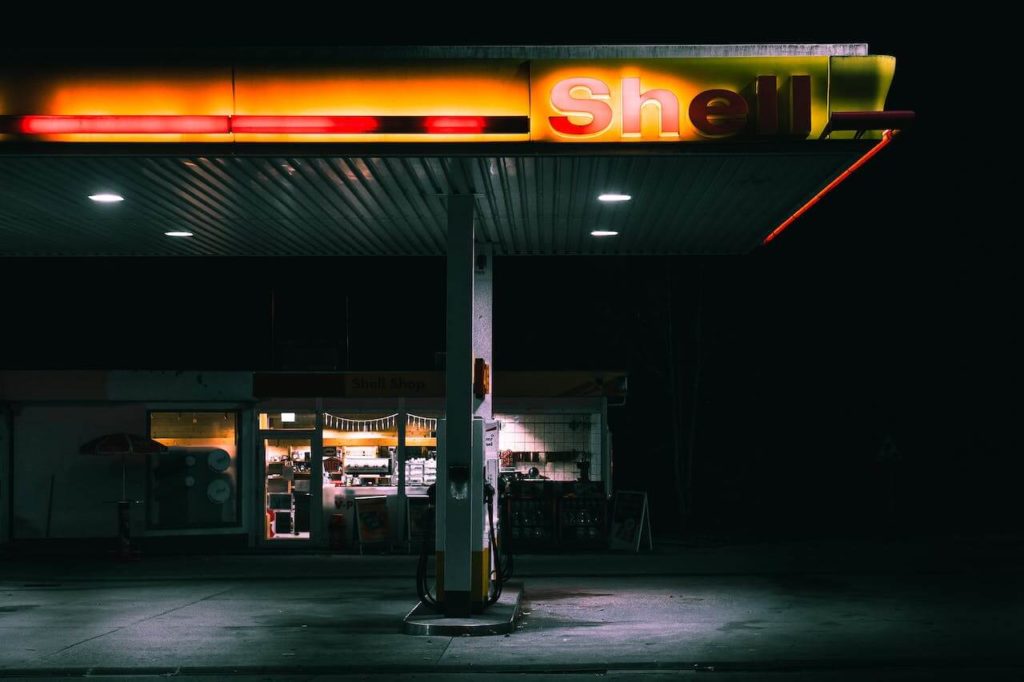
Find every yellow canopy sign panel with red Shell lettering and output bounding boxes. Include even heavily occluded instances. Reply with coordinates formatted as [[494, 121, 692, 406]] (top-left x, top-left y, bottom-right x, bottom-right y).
[[530, 56, 828, 142]]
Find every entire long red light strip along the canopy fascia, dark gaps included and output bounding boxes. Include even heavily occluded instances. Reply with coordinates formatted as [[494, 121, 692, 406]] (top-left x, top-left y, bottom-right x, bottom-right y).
[[8, 116, 529, 135]]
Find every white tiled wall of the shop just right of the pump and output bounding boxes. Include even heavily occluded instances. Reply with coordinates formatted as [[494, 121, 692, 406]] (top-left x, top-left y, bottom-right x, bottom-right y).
[[495, 413, 601, 480]]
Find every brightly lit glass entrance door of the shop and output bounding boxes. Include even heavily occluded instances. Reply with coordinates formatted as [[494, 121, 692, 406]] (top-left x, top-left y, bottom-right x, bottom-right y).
[[260, 433, 324, 547]]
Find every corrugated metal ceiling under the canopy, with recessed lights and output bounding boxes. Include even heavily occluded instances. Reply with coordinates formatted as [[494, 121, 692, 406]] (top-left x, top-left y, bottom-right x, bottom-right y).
[[0, 146, 869, 256]]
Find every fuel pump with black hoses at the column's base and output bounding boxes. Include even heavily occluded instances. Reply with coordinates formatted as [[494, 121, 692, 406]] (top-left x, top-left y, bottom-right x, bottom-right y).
[[416, 418, 512, 616]]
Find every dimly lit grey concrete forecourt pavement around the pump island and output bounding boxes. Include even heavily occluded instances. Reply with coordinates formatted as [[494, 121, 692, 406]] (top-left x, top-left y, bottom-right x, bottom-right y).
[[0, 532, 1024, 682]]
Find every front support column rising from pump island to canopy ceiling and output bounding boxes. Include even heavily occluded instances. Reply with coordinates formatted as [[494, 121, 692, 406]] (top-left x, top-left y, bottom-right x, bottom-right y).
[[437, 195, 473, 617]]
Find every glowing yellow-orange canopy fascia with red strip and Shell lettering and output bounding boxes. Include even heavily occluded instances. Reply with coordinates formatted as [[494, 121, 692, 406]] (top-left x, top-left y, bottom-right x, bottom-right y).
[[0, 56, 895, 143]]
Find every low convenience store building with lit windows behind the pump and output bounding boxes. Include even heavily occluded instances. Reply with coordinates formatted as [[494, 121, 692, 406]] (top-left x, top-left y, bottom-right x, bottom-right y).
[[0, 371, 626, 552]]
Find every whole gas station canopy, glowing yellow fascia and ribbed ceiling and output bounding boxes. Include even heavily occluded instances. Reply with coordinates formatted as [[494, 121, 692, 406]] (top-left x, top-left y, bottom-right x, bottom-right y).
[[0, 44, 908, 256]]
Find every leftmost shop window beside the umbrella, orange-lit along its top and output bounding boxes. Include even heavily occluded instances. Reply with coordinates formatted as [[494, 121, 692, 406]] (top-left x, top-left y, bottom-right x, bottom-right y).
[[146, 412, 242, 529]]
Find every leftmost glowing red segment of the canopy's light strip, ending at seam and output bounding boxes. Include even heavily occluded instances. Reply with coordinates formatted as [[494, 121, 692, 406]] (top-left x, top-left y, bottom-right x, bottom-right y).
[[17, 116, 230, 135]]
